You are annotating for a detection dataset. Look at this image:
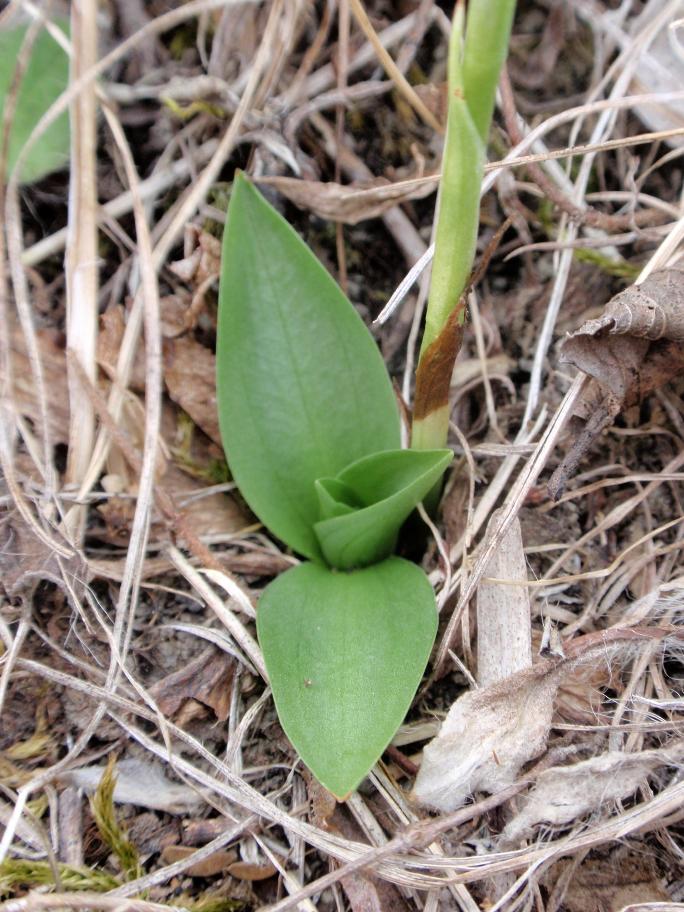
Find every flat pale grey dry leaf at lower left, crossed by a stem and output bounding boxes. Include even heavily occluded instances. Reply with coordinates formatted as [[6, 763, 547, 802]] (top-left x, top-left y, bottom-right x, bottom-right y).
[[60, 759, 203, 814]]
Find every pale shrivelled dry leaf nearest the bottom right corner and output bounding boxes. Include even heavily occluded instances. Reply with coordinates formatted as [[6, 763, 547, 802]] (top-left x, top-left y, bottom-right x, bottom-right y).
[[501, 749, 681, 844]]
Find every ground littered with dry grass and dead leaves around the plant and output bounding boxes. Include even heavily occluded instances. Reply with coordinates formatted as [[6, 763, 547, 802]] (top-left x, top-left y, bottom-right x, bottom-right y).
[[0, 0, 684, 912]]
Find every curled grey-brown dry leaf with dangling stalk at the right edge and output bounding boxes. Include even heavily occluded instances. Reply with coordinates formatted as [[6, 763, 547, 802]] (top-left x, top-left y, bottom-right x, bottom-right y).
[[549, 269, 684, 500]]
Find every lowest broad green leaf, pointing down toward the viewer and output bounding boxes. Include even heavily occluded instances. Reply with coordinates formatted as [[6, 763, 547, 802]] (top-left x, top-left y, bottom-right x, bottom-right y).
[[257, 557, 437, 798]]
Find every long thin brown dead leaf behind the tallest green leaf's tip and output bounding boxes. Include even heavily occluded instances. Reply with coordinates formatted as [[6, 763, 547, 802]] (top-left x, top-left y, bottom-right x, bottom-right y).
[[256, 175, 439, 225]]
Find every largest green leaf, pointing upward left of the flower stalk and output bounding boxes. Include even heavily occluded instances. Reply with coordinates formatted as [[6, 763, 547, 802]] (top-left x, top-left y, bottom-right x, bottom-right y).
[[216, 176, 399, 560]]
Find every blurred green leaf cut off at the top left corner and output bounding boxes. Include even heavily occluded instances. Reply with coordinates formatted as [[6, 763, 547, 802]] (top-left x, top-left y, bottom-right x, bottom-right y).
[[0, 20, 69, 183]]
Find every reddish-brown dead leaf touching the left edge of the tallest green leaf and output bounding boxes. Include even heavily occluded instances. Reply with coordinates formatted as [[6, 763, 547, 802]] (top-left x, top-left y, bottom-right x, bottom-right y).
[[164, 336, 221, 446]]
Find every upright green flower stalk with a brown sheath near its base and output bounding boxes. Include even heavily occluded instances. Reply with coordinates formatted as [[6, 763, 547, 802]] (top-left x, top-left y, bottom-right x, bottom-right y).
[[411, 0, 515, 450]]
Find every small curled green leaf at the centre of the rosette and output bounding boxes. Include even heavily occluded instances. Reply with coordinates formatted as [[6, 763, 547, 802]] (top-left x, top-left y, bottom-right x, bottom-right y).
[[314, 450, 453, 570]]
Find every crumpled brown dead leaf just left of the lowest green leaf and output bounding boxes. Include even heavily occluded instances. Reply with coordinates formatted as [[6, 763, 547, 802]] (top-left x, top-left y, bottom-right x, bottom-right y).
[[150, 646, 235, 722]]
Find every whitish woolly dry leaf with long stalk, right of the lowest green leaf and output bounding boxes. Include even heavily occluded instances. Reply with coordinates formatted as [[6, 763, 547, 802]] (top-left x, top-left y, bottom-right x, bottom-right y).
[[413, 627, 680, 811]]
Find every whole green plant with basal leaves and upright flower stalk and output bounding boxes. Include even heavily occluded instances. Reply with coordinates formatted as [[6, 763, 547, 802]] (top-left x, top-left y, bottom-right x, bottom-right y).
[[217, 0, 514, 798]]
